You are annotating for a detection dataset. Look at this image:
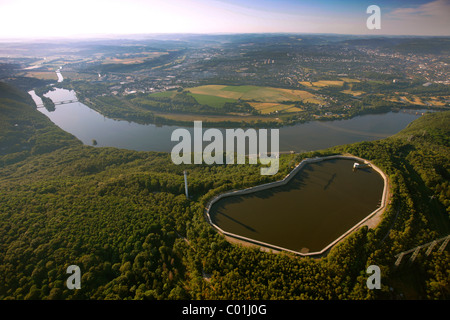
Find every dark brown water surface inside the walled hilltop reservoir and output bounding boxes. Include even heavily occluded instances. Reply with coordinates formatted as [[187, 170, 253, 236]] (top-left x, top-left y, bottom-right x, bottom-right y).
[[210, 159, 384, 252]]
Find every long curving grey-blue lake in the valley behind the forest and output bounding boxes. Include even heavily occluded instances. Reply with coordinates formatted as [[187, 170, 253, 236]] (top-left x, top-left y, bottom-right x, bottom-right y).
[[29, 88, 426, 152]]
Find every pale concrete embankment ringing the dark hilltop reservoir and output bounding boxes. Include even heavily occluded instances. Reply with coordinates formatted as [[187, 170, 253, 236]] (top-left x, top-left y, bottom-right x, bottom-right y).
[[205, 155, 389, 256]]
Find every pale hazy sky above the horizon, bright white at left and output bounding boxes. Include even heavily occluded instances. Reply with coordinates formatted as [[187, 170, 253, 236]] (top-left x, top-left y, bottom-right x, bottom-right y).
[[0, 0, 450, 39]]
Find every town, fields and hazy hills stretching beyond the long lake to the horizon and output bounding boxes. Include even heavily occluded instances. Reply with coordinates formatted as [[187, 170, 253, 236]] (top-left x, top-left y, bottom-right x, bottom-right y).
[[0, 34, 450, 126]]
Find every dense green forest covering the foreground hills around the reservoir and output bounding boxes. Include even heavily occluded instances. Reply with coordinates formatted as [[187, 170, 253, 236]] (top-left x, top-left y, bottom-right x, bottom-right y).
[[0, 84, 450, 299]]
